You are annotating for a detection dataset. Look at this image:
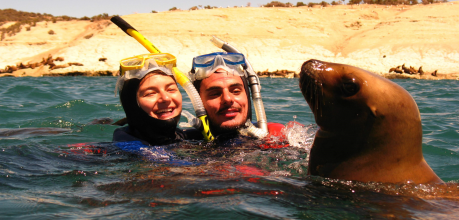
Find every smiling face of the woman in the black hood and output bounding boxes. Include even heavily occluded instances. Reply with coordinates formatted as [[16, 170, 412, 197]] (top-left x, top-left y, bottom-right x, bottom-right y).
[[137, 74, 182, 120]]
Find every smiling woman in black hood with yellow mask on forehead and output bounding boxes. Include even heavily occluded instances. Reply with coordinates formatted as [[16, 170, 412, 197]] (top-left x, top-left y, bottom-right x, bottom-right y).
[[113, 53, 202, 145]]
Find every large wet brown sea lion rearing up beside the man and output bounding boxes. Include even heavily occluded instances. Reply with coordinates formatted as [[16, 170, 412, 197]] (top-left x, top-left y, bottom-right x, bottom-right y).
[[299, 60, 442, 183]]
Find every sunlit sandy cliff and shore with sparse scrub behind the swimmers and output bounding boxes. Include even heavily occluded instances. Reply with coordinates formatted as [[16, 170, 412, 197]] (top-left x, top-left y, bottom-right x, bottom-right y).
[[0, 0, 459, 80]]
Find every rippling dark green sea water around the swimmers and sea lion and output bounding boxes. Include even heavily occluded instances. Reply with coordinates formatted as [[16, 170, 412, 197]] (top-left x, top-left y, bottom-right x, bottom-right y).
[[0, 77, 459, 219]]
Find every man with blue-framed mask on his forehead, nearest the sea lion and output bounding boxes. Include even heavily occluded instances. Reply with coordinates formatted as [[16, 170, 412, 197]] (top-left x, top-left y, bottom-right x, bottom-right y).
[[189, 52, 284, 137]]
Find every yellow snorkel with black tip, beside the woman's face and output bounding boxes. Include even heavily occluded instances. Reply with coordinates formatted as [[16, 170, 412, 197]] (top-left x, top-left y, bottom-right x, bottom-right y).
[[110, 16, 214, 141]]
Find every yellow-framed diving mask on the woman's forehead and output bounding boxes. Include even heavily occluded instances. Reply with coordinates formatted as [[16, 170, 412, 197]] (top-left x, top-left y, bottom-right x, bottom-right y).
[[115, 53, 177, 93]]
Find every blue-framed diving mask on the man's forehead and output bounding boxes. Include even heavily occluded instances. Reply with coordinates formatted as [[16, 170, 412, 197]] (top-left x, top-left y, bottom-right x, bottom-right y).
[[189, 52, 245, 81]]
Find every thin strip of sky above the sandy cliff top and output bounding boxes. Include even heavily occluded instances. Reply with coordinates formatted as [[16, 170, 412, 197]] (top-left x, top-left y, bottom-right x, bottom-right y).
[[0, 0, 324, 18]]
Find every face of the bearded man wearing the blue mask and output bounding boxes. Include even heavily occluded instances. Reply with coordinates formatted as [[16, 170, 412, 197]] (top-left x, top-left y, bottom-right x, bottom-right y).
[[200, 69, 248, 131]]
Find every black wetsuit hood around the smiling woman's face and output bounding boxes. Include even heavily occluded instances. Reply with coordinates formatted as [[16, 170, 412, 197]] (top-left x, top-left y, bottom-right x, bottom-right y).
[[120, 78, 180, 145]]
